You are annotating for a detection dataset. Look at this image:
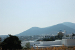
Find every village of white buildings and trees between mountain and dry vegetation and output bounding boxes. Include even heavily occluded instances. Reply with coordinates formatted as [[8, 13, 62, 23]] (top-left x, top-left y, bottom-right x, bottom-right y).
[[0, 30, 75, 49]]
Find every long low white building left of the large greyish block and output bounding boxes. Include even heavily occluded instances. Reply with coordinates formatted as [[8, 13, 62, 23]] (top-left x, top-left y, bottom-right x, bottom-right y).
[[33, 40, 62, 47]]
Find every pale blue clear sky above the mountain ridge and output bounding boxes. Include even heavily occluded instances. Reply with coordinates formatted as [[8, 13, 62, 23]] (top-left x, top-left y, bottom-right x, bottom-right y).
[[0, 0, 75, 35]]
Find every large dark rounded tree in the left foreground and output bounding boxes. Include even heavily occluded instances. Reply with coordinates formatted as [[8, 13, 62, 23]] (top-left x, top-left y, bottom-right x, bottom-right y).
[[1, 35, 22, 50]]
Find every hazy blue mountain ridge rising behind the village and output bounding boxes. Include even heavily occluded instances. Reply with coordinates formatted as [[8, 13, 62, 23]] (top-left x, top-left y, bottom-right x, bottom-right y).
[[17, 22, 75, 36]]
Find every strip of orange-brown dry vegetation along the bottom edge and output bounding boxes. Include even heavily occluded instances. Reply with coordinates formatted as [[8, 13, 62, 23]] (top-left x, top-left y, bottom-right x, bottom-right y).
[[0, 45, 75, 50]]
